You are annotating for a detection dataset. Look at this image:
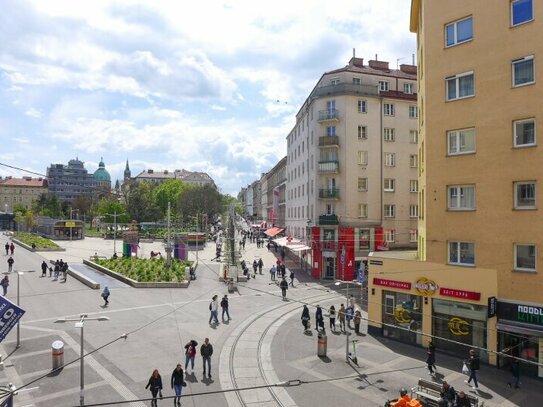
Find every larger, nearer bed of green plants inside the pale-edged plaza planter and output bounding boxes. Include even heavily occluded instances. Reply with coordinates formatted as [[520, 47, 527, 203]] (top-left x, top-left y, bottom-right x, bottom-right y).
[[93, 258, 192, 283]]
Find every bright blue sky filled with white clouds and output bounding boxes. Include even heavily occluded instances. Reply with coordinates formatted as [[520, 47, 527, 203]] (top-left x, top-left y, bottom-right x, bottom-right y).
[[0, 0, 416, 196]]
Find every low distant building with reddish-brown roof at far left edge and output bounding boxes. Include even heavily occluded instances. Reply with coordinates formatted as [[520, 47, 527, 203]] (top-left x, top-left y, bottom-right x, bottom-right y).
[[0, 177, 47, 212]]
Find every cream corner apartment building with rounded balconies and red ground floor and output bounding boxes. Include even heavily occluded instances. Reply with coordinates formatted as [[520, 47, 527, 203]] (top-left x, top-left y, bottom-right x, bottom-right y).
[[286, 57, 418, 279]]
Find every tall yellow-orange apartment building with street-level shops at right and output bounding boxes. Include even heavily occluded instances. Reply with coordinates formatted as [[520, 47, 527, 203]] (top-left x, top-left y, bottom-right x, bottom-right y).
[[369, 0, 543, 377]]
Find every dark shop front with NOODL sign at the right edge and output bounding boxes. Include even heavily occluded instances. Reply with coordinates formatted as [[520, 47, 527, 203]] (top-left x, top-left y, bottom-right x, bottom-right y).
[[497, 300, 543, 377]]
